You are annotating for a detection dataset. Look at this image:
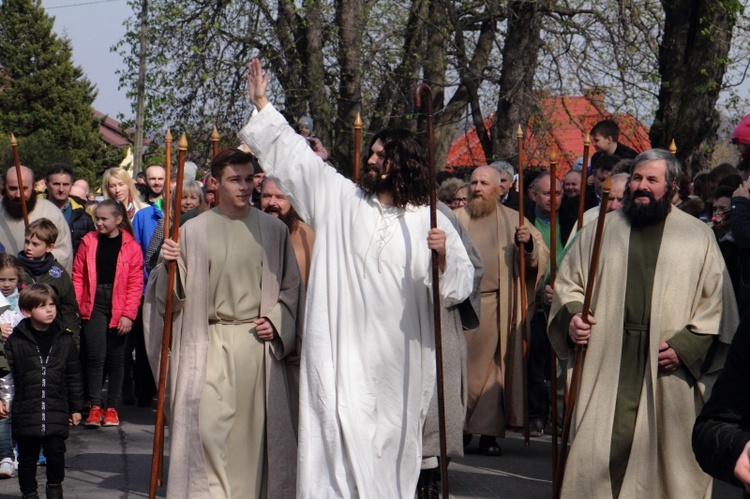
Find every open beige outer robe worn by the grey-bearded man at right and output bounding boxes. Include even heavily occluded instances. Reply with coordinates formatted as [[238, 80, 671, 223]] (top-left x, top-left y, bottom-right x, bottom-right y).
[[549, 209, 738, 499]]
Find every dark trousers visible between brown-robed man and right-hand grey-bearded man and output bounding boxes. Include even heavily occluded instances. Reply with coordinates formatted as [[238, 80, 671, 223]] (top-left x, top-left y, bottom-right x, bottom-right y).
[[527, 312, 550, 422]]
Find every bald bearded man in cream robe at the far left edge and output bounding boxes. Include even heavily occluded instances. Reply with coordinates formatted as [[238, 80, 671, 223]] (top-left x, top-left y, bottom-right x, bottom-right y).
[[0, 166, 73, 272]]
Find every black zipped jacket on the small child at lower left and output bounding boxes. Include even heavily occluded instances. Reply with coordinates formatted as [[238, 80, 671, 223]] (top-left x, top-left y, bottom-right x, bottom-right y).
[[5, 319, 83, 439]]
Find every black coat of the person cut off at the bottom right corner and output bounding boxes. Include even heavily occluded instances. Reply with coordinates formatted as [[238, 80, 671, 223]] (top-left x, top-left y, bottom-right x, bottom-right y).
[[693, 310, 750, 487]]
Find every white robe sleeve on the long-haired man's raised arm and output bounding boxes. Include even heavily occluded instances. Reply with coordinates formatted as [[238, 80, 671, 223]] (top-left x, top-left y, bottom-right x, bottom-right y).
[[239, 104, 357, 229]]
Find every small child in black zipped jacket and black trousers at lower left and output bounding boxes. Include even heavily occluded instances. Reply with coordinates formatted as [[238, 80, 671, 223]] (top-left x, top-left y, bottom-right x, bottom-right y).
[[0, 284, 83, 499]]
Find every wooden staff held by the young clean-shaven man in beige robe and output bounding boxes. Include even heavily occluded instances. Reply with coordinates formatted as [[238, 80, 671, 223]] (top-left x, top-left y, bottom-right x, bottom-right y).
[[148, 132, 187, 499]]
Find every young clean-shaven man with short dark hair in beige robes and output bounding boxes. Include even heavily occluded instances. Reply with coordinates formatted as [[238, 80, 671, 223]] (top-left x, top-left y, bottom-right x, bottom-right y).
[[144, 150, 302, 499]]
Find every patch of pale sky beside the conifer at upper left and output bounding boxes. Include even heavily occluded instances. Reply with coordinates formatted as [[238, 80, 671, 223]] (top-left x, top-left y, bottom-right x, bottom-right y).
[[42, 0, 135, 118]]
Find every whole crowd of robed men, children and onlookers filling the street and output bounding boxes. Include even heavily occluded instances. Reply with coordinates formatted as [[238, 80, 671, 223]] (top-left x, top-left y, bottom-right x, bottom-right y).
[[0, 56, 750, 498]]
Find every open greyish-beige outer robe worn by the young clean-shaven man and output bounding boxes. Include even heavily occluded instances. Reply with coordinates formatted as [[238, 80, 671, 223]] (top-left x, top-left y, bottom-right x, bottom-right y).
[[143, 209, 302, 499]]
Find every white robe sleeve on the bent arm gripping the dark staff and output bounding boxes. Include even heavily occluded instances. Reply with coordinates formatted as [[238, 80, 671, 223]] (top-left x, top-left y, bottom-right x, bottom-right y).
[[432, 212, 474, 307]]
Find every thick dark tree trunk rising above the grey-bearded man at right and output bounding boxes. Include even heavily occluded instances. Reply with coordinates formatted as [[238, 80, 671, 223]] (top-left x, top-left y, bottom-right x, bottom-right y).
[[649, 0, 741, 172]]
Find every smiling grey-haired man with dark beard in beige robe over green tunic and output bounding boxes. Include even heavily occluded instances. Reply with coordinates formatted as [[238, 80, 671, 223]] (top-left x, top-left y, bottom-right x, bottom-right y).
[[549, 149, 738, 498]]
